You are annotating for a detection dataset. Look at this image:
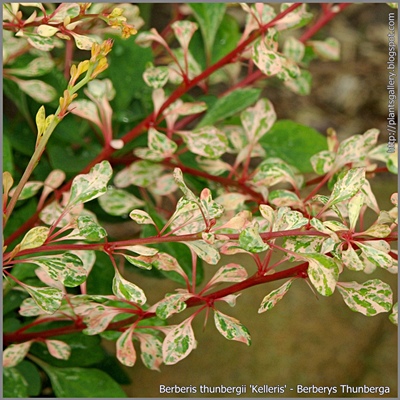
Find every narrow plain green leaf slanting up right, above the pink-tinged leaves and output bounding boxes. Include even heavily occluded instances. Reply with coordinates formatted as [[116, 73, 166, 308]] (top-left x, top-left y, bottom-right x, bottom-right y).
[[197, 89, 261, 128]]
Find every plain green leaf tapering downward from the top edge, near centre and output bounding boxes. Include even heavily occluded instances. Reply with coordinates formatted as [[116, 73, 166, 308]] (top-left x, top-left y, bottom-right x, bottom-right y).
[[189, 3, 226, 60]]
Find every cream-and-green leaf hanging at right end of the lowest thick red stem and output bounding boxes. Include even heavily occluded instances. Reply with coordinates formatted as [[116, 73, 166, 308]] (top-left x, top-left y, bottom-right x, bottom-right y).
[[302, 253, 339, 296]]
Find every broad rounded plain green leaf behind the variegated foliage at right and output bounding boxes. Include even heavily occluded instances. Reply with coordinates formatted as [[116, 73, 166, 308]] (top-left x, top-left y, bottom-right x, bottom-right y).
[[260, 120, 327, 173]]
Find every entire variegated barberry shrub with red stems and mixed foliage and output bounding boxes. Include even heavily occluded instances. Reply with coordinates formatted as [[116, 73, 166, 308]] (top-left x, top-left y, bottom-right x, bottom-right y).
[[3, 3, 397, 397]]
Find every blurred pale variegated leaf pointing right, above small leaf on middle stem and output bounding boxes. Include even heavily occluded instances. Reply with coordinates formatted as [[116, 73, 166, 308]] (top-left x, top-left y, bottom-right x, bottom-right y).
[[98, 188, 145, 216]]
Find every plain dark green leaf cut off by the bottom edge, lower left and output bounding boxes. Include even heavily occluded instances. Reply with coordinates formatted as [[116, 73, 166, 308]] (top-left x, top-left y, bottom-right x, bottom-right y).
[[39, 363, 127, 398]]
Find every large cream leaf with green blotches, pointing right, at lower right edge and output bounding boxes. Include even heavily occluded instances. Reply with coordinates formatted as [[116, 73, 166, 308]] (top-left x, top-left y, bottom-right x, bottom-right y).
[[337, 279, 393, 317]]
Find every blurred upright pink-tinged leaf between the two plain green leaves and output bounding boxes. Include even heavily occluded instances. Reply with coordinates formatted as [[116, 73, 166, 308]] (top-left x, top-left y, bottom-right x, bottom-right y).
[[240, 99, 276, 143]]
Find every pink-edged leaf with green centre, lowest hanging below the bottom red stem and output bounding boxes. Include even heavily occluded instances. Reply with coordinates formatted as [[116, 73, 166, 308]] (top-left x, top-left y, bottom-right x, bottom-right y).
[[162, 317, 197, 365]]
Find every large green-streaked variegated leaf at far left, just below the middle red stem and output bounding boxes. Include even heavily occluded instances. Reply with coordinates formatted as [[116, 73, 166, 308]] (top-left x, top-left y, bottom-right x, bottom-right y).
[[30, 252, 87, 287]]
